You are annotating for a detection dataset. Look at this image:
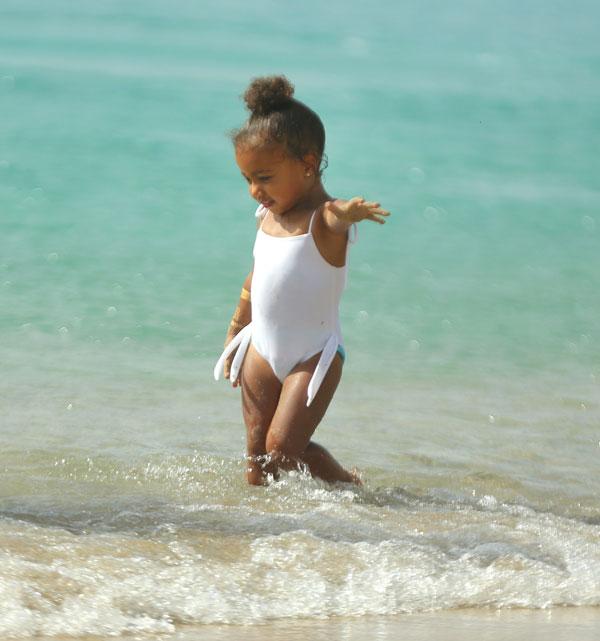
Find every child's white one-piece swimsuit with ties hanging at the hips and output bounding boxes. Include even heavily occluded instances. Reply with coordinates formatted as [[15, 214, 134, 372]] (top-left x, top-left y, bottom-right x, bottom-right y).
[[214, 205, 356, 406]]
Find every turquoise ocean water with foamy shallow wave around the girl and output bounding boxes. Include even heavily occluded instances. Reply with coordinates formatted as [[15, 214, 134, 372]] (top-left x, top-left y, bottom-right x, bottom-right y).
[[0, 0, 600, 638]]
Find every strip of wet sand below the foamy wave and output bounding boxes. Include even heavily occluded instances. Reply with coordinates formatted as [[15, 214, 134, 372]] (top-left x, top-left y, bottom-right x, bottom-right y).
[[17, 607, 600, 641]]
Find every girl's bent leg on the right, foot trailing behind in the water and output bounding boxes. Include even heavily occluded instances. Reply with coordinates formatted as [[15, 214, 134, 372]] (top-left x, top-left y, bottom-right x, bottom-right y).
[[265, 354, 360, 483]]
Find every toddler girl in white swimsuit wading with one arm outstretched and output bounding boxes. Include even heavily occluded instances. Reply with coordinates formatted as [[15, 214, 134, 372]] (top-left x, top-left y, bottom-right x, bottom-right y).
[[215, 76, 389, 485]]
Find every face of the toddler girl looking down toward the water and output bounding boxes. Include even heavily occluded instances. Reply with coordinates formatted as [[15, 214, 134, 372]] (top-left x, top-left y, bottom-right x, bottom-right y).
[[235, 146, 311, 214]]
